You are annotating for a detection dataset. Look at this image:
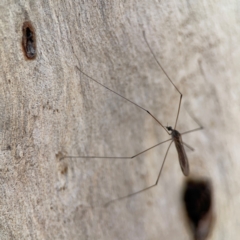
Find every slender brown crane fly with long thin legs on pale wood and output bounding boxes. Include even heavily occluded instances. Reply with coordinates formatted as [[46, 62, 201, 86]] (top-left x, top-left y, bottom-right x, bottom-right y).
[[60, 31, 203, 206]]
